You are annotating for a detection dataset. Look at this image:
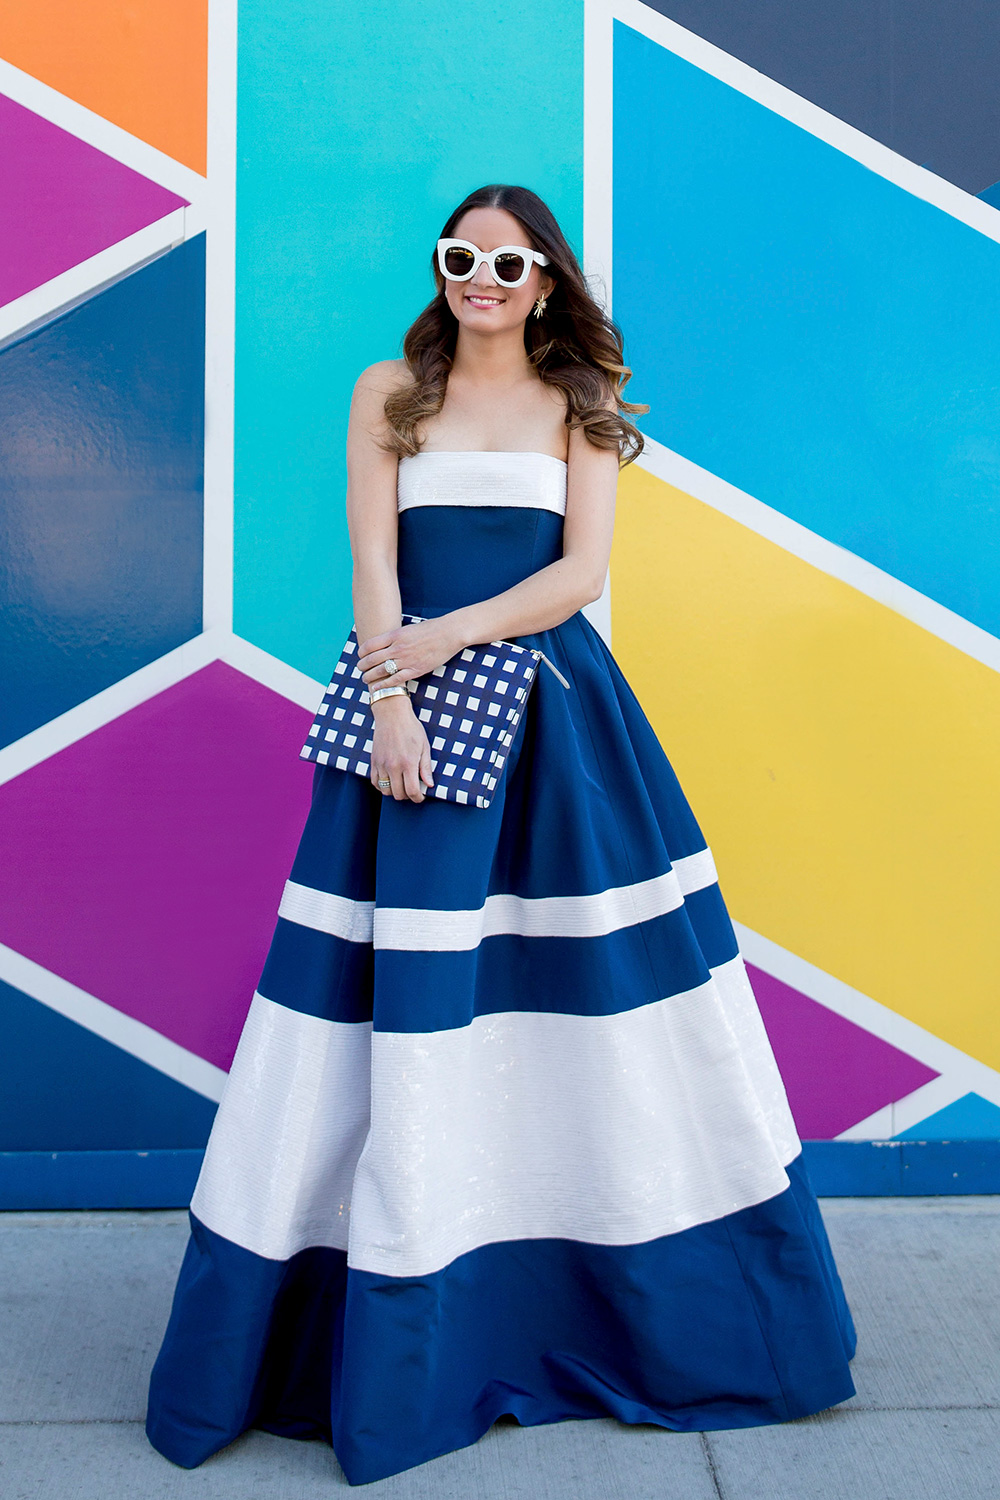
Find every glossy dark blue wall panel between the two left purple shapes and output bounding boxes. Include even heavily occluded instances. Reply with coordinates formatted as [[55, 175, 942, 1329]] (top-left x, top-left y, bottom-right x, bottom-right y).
[[0, 236, 205, 744]]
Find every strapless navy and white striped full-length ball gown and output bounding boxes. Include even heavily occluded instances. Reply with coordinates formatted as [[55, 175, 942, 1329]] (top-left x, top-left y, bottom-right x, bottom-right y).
[[147, 452, 855, 1484]]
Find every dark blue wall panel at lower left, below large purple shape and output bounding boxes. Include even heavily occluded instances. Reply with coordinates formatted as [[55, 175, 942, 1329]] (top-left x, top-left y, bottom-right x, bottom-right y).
[[0, 983, 216, 1152]]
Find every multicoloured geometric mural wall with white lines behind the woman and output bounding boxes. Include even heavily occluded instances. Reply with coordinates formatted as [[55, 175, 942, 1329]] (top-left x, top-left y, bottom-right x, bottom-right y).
[[0, 0, 1000, 1206]]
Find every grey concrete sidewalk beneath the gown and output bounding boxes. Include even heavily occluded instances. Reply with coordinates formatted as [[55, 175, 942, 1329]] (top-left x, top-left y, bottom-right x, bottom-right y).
[[0, 1197, 1000, 1500]]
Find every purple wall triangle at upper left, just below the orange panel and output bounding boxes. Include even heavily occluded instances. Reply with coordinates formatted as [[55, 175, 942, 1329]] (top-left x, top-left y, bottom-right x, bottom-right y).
[[0, 95, 187, 306]]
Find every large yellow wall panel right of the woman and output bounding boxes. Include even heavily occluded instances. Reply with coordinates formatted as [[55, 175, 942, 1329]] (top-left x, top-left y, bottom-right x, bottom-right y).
[[612, 467, 1000, 1068]]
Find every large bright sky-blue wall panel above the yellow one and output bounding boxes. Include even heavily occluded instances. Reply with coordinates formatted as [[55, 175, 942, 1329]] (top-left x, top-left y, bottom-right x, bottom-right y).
[[613, 24, 1000, 633]]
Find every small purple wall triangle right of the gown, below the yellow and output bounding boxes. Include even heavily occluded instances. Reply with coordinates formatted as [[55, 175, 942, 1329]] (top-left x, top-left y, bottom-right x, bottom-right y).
[[747, 965, 937, 1140]]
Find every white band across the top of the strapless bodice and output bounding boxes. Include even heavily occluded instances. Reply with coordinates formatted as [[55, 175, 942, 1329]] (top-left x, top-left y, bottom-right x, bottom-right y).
[[396, 449, 567, 516]]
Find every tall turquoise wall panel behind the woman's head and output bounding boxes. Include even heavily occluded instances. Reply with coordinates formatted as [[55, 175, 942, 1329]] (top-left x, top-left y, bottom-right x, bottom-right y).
[[234, 0, 583, 681]]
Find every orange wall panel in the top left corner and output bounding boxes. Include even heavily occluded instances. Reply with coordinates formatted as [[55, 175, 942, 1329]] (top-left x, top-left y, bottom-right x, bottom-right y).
[[0, 0, 208, 173]]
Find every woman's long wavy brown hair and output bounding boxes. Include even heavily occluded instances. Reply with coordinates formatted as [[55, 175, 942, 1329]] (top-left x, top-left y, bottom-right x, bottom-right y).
[[385, 183, 649, 464]]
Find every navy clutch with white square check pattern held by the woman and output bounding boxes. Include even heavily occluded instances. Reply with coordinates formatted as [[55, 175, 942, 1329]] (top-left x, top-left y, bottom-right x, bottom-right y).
[[298, 615, 570, 807]]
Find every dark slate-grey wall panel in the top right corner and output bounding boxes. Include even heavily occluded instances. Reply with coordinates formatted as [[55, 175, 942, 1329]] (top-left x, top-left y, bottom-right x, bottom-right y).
[[646, 0, 1000, 192]]
